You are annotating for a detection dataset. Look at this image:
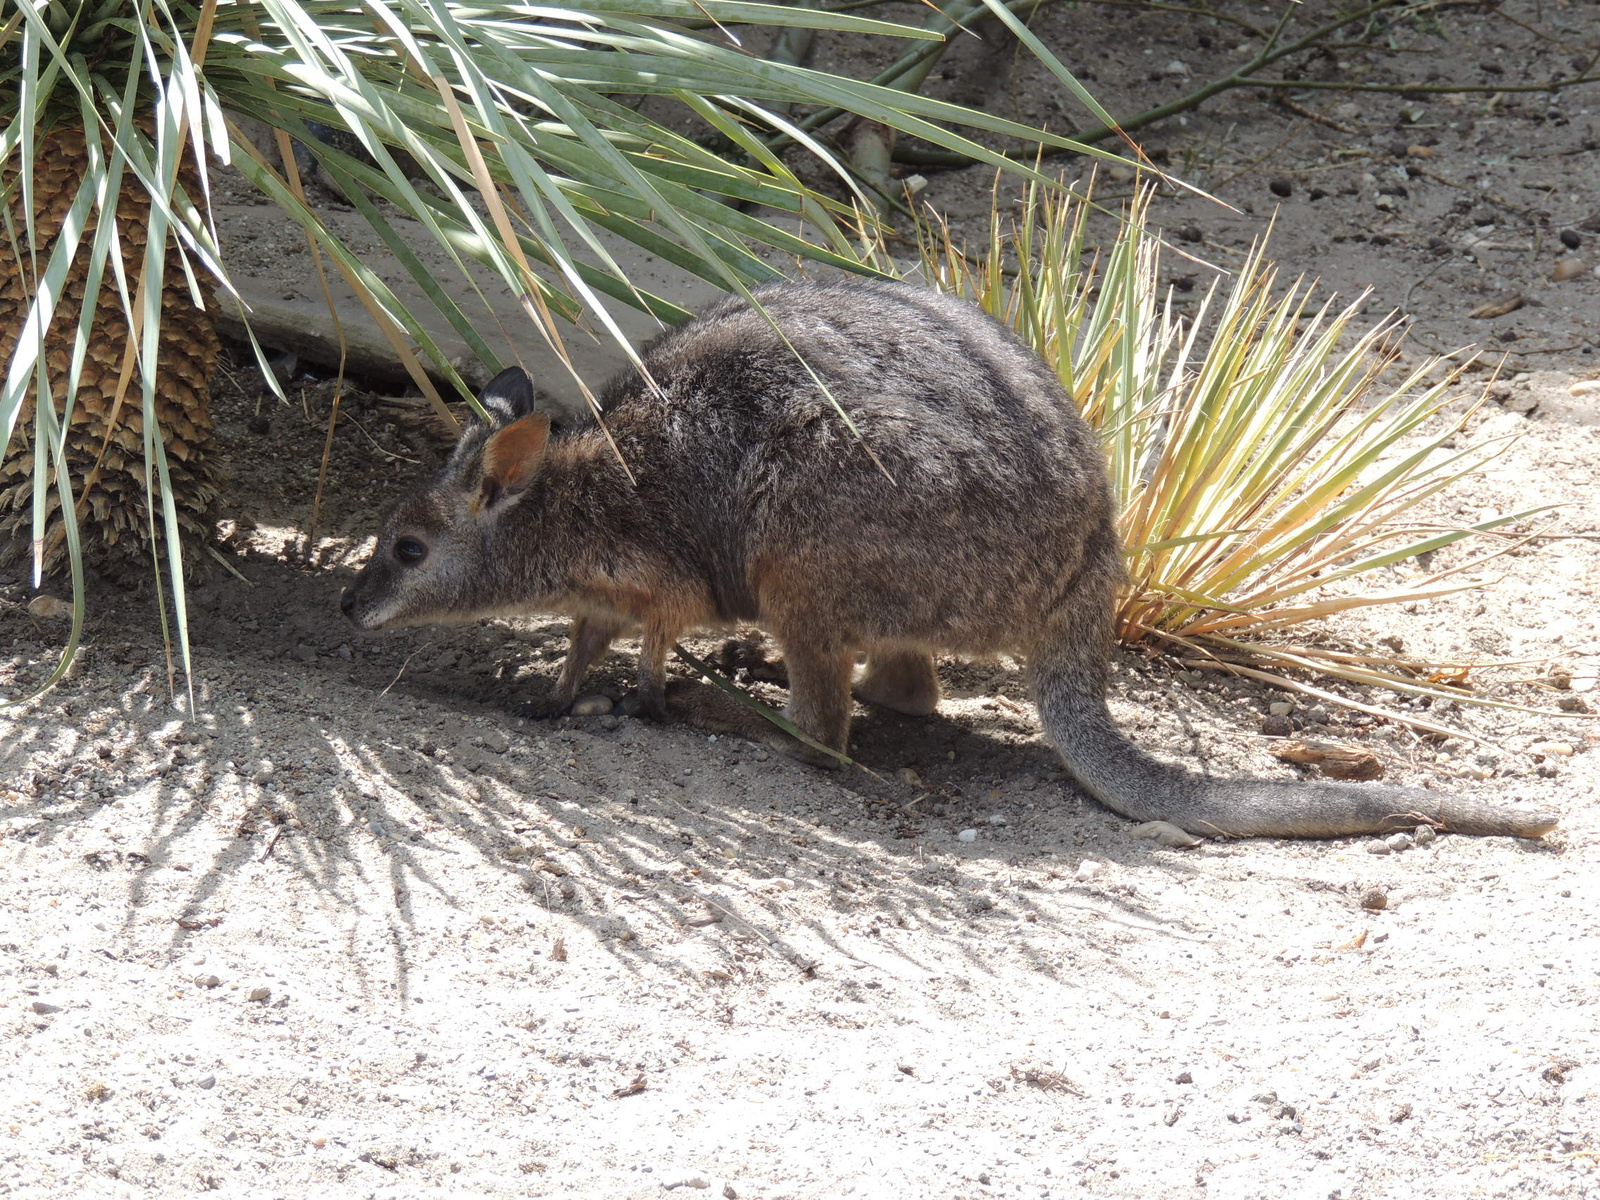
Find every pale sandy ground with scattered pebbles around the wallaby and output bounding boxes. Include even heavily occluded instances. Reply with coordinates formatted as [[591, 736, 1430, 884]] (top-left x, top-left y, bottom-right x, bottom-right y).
[[0, 0, 1600, 1200]]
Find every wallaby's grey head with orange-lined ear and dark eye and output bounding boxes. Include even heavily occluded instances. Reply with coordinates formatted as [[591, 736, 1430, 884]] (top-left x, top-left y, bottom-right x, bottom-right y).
[[339, 366, 550, 629]]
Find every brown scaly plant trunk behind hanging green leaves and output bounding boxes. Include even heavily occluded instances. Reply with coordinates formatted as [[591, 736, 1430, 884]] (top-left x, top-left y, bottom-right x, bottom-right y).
[[0, 130, 219, 573]]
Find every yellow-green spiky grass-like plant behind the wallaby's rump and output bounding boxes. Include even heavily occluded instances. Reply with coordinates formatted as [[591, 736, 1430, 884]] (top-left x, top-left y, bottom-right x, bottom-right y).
[[922, 190, 1539, 713]]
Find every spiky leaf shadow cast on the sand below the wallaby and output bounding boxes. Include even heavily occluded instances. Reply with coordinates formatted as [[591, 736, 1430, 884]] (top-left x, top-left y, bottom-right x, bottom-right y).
[[0, 540, 1248, 998]]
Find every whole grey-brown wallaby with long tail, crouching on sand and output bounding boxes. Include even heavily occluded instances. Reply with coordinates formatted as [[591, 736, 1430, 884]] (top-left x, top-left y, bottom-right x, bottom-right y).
[[342, 280, 1555, 837]]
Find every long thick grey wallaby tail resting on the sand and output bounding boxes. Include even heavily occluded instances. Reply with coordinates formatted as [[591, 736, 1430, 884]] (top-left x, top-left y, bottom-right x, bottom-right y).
[[1030, 650, 1557, 837]]
